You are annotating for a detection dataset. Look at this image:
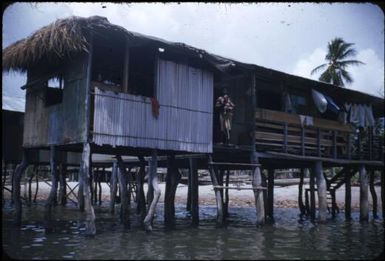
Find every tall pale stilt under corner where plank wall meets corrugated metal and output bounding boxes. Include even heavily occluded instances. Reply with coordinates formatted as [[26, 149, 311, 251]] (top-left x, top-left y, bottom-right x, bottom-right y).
[[80, 143, 96, 236]]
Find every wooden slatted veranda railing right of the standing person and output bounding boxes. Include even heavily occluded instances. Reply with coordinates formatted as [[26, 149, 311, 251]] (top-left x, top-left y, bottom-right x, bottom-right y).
[[255, 109, 383, 160]]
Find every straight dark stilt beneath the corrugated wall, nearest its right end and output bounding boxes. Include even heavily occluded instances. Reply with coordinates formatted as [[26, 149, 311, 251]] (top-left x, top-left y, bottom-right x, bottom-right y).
[[189, 158, 199, 226]]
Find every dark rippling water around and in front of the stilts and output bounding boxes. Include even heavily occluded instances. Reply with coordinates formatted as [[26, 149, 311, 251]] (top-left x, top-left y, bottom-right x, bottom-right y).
[[2, 202, 384, 260]]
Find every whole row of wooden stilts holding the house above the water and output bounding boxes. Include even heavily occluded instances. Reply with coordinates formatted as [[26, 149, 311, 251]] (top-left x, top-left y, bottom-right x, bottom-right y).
[[9, 143, 384, 235]]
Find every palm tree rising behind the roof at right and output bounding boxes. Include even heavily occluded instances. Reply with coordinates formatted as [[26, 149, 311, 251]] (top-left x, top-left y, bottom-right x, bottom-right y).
[[311, 37, 364, 87]]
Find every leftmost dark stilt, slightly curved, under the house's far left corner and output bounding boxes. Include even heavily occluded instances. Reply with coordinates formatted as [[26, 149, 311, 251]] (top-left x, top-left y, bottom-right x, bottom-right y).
[[12, 149, 28, 226]]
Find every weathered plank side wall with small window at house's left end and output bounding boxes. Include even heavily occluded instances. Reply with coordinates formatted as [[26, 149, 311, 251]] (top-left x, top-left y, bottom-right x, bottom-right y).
[[23, 55, 87, 147]]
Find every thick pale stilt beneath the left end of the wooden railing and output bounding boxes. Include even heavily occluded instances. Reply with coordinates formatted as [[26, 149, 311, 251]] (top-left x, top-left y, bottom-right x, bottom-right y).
[[251, 151, 265, 226]]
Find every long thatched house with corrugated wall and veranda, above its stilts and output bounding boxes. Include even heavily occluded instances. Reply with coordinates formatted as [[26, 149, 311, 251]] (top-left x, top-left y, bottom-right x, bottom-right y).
[[3, 16, 384, 232]]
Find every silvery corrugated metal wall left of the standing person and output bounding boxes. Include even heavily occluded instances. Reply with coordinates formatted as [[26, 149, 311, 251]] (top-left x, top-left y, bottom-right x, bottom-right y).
[[93, 60, 213, 153]]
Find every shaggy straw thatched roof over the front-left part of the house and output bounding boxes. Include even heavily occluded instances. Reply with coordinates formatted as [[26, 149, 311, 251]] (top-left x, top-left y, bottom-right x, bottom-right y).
[[3, 16, 243, 71]]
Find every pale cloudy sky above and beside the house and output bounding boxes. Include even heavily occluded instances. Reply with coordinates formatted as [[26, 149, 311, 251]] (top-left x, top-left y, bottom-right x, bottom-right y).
[[2, 2, 384, 111]]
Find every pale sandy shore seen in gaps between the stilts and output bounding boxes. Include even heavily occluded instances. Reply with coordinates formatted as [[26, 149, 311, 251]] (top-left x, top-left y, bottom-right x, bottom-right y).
[[3, 182, 382, 210]]
